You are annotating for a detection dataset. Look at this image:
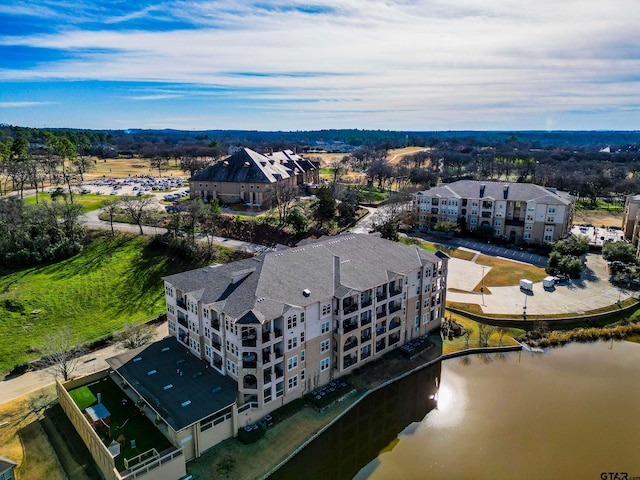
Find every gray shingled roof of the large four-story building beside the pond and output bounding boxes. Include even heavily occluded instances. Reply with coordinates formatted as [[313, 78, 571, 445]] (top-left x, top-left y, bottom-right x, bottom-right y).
[[165, 234, 446, 320]]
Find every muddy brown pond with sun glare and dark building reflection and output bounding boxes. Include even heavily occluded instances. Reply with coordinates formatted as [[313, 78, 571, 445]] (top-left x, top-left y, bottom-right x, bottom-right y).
[[272, 342, 640, 480]]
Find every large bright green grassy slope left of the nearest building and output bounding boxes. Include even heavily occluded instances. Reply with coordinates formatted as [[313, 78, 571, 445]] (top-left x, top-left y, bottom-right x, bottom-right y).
[[0, 233, 198, 372]]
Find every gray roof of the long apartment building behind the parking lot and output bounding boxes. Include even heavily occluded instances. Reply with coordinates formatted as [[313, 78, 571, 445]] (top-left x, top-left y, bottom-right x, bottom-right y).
[[418, 180, 571, 205]]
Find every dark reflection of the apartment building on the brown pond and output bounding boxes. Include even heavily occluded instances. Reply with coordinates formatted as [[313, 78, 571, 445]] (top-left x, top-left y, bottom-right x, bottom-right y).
[[270, 362, 442, 480]]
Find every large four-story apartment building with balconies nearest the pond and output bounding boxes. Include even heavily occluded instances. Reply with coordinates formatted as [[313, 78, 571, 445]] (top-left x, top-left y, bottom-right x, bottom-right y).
[[164, 234, 448, 419]]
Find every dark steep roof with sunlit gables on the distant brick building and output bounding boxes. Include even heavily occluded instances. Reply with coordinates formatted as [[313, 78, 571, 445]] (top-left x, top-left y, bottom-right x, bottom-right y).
[[190, 148, 292, 183]]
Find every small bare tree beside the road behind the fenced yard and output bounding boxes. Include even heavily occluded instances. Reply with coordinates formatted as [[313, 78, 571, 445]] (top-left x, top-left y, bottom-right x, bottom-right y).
[[41, 327, 84, 382]]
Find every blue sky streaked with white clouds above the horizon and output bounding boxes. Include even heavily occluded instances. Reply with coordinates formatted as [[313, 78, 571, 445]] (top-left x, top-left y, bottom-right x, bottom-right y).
[[0, 0, 640, 130]]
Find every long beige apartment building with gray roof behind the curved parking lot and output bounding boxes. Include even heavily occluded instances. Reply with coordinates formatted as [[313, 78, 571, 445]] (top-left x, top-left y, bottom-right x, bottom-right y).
[[413, 180, 574, 244]]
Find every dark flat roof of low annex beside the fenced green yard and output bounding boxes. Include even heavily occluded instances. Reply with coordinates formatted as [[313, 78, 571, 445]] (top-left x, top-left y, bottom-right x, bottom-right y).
[[106, 337, 238, 431]]
